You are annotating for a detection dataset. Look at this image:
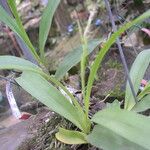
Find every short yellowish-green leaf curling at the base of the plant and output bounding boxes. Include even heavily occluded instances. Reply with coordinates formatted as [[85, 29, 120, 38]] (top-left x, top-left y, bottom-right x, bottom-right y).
[[56, 128, 87, 144]]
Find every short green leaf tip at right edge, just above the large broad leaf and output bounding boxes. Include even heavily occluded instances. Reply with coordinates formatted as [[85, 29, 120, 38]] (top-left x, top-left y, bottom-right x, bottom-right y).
[[132, 94, 150, 112]]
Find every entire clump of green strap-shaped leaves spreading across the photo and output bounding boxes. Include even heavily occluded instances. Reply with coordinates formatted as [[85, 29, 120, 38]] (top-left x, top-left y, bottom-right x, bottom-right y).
[[0, 0, 150, 150]]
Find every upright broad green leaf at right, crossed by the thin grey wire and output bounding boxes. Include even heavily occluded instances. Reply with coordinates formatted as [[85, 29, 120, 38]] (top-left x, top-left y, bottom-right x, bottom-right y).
[[125, 49, 150, 110]]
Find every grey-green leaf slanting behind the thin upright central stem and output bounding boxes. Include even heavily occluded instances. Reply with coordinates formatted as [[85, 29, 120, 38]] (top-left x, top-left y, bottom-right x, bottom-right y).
[[55, 39, 102, 80]]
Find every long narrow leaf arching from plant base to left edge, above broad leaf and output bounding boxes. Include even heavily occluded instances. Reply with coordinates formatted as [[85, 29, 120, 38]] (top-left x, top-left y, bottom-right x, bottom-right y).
[[0, 56, 90, 133]]
